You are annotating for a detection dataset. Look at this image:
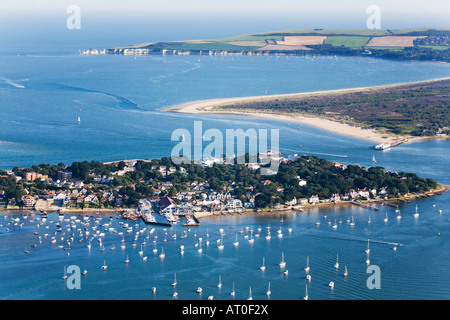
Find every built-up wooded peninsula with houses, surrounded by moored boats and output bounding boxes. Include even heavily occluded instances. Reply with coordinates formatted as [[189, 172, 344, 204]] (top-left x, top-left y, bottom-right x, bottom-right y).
[[0, 152, 447, 222]]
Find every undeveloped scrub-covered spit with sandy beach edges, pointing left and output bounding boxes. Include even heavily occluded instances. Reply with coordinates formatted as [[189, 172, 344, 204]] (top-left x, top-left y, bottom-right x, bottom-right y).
[[165, 78, 450, 146]]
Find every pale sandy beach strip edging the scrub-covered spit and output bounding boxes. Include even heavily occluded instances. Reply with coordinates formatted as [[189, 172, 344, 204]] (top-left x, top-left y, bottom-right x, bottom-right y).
[[163, 77, 450, 146]]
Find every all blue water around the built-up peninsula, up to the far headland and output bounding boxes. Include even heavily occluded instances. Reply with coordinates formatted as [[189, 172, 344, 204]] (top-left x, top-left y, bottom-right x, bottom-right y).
[[0, 46, 450, 300]]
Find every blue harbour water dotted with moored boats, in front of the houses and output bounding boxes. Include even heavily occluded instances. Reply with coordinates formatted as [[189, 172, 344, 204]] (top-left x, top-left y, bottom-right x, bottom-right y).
[[0, 194, 450, 300]]
